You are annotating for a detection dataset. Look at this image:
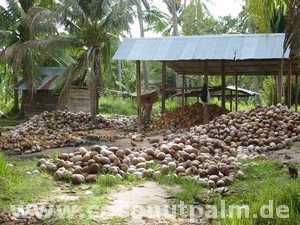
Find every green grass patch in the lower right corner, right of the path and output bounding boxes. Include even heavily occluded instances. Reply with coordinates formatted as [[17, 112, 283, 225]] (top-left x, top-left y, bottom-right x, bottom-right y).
[[213, 161, 300, 225]]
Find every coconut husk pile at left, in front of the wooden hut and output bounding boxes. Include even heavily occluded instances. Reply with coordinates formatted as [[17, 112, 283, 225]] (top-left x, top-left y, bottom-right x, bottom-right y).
[[0, 110, 135, 154]]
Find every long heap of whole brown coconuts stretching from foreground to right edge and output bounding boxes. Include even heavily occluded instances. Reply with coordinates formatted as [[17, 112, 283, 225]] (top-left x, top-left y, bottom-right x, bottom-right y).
[[38, 105, 300, 187]]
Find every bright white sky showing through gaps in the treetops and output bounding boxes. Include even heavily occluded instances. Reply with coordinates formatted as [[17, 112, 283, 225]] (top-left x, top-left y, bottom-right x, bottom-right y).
[[0, 0, 244, 37]]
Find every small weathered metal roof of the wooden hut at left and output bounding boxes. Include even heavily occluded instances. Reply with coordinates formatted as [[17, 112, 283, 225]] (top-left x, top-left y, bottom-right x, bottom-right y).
[[13, 67, 65, 91]]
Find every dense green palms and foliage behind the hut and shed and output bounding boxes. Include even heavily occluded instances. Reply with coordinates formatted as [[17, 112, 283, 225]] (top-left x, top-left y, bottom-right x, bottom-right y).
[[0, 0, 298, 115]]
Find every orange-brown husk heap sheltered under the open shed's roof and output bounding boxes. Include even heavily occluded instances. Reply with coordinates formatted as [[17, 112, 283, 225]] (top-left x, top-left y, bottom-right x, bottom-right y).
[[150, 103, 229, 133]]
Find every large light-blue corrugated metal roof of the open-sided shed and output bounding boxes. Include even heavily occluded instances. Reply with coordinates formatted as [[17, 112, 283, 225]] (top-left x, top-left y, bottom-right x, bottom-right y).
[[113, 33, 290, 61]]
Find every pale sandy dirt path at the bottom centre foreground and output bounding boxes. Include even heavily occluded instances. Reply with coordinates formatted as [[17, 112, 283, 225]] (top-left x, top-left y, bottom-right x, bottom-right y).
[[100, 181, 185, 225]]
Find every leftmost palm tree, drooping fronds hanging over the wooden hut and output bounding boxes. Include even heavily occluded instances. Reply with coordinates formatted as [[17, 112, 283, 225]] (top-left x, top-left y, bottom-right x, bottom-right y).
[[0, 0, 56, 111]]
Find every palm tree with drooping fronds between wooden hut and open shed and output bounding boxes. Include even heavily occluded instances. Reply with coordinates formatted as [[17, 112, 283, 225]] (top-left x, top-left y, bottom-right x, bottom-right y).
[[56, 0, 133, 124]]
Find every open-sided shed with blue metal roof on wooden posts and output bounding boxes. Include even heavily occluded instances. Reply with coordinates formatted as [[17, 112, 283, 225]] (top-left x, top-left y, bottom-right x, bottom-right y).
[[113, 33, 300, 131]]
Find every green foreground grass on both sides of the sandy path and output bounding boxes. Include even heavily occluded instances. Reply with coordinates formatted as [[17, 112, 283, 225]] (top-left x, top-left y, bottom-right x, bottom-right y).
[[0, 149, 300, 225]]
